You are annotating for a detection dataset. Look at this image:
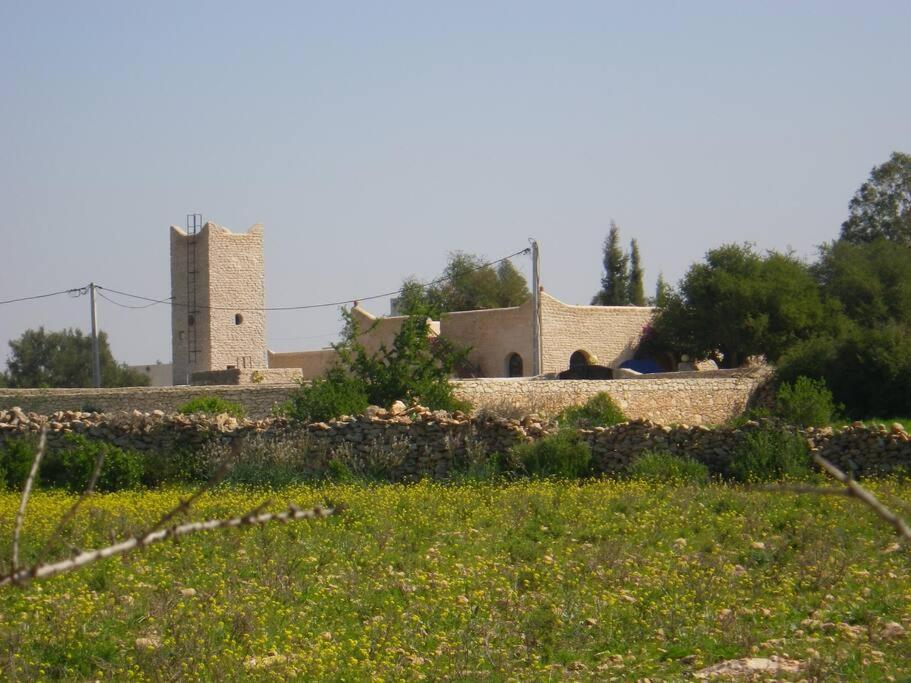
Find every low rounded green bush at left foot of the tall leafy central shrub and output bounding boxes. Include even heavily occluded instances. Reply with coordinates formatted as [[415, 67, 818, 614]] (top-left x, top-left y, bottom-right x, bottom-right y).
[[280, 368, 369, 422]]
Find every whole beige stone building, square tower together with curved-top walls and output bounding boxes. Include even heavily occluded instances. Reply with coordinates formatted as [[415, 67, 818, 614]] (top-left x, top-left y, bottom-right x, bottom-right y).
[[171, 223, 653, 384]]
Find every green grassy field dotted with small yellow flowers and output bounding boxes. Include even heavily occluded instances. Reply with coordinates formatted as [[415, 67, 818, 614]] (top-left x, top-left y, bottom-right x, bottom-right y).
[[0, 481, 911, 681]]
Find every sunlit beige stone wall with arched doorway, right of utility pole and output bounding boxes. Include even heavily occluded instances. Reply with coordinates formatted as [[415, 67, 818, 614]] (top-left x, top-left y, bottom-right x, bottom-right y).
[[541, 292, 655, 373]]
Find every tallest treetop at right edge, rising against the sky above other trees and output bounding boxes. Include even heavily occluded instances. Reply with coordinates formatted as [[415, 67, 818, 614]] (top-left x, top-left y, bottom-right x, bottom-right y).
[[841, 152, 911, 247]]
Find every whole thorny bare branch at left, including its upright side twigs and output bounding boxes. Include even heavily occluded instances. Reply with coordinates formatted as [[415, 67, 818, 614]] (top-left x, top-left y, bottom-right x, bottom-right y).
[[0, 438, 342, 588]]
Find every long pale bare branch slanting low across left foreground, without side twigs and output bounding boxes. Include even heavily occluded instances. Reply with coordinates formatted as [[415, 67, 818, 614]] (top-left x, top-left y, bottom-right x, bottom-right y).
[[0, 506, 335, 587]]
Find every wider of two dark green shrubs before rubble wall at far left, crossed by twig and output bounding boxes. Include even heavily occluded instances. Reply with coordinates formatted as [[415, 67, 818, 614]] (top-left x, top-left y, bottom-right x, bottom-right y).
[[41, 434, 144, 491]]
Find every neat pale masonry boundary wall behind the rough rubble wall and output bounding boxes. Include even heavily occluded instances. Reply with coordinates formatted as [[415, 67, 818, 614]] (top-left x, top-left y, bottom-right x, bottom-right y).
[[0, 371, 767, 424]]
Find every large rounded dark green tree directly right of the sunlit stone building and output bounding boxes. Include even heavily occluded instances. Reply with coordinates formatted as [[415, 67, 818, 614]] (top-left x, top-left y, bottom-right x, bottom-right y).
[[650, 244, 831, 368]]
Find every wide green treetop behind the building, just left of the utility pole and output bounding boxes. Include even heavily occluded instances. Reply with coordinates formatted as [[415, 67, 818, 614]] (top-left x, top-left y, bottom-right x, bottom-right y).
[[397, 251, 531, 318]]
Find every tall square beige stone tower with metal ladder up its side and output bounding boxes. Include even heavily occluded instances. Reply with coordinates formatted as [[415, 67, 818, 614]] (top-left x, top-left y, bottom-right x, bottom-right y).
[[171, 223, 267, 384]]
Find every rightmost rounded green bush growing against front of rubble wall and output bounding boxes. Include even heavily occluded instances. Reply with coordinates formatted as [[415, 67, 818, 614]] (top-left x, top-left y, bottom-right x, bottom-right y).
[[728, 427, 811, 483]]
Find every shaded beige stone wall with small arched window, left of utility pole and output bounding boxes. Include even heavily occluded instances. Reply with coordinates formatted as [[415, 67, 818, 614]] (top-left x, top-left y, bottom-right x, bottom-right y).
[[440, 300, 534, 377]]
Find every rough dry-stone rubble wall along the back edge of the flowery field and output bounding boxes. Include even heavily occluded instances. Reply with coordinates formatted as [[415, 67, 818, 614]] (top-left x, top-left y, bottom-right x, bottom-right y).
[[0, 403, 911, 479]]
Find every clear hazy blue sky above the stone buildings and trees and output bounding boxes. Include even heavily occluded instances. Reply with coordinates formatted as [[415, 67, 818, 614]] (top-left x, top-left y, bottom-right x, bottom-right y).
[[0, 0, 911, 364]]
